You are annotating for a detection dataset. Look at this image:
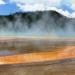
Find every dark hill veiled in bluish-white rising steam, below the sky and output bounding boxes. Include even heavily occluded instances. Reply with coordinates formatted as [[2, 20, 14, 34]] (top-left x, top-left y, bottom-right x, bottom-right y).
[[0, 11, 75, 36]]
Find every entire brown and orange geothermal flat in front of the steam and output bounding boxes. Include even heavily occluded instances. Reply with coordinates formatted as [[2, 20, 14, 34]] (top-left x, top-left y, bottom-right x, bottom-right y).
[[0, 38, 75, 75]]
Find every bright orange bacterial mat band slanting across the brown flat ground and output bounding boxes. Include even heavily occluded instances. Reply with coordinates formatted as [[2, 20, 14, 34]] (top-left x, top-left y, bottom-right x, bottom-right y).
[[0, 46, 75, 65]]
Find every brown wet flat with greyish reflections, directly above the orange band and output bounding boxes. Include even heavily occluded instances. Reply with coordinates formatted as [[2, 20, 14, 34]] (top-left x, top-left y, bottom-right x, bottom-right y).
[[0, 39, 75, 56]]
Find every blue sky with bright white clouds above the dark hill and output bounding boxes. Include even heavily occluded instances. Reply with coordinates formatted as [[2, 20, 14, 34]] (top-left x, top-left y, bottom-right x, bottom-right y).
[[0, 0, 75, 18]]
